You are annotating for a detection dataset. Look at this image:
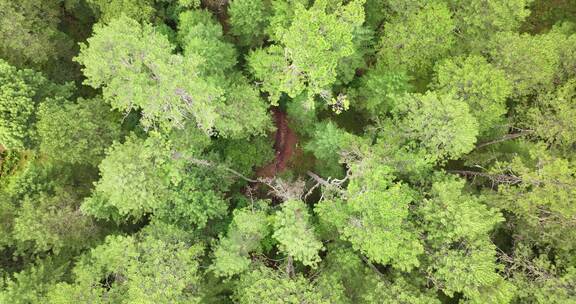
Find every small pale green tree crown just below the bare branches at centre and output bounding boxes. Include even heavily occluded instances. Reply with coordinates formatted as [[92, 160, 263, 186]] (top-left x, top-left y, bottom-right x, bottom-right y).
[[273, 200, 323, 267]]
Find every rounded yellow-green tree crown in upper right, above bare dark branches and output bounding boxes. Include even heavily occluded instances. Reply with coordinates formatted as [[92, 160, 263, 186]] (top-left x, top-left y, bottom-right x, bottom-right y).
[[433, 56, 512, 135]]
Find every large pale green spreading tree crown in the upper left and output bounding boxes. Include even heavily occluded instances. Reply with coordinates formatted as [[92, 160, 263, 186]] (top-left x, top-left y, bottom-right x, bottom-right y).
[[76, 16, 223, 134]]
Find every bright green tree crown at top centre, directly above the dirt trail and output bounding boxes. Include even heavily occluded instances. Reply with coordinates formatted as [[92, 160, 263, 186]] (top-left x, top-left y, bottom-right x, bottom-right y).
[[248, 0, 364, 104]]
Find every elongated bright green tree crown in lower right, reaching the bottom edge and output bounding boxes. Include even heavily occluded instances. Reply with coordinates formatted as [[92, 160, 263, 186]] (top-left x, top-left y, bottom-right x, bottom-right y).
[[420, 178, 514, 303]]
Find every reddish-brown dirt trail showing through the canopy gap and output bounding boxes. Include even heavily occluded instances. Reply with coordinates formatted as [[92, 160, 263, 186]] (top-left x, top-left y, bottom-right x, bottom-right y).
[[256, 108, 298, 177]]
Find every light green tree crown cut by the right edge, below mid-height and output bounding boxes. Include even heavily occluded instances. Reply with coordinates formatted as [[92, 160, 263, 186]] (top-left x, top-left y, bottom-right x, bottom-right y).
[[493, 146, 576, 254]]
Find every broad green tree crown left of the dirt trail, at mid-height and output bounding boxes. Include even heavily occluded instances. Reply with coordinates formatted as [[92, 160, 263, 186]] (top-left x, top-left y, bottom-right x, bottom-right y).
[[82, 129, 229, 229]]
